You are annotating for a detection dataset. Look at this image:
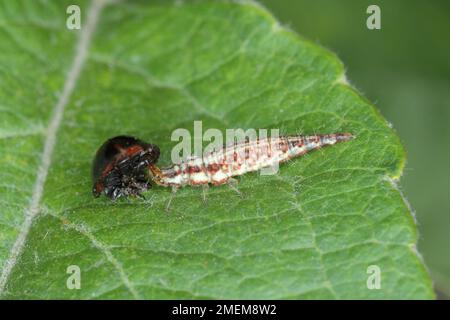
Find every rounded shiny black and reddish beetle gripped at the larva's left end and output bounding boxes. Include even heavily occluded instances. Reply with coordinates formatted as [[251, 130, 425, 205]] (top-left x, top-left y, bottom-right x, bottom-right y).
[[92, 136, 160, 200]]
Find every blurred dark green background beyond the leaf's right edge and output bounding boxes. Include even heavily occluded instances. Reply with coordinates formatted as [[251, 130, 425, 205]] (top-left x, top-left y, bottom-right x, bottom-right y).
[[260, 0, 450, 299]]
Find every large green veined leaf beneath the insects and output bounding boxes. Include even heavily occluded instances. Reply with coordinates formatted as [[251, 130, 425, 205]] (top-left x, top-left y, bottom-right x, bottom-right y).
[[0, 0, 434, 299]]
